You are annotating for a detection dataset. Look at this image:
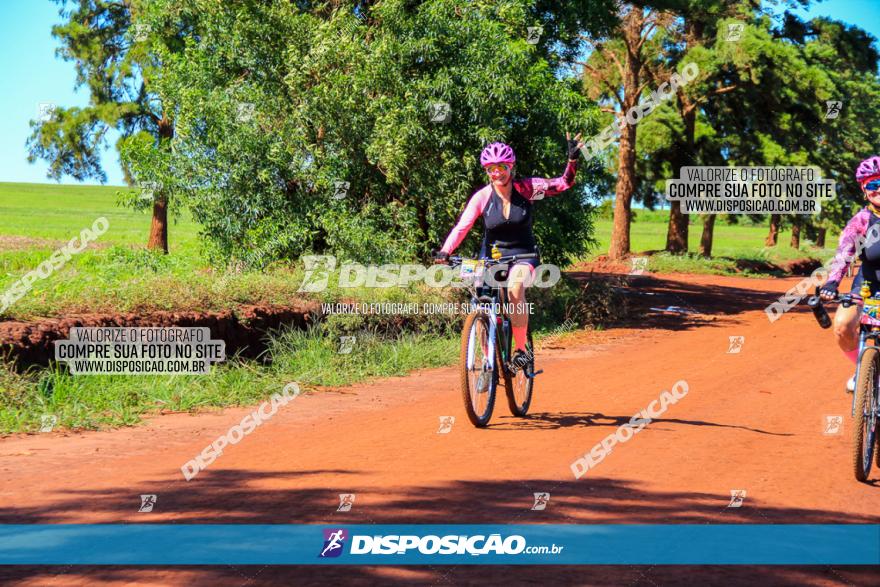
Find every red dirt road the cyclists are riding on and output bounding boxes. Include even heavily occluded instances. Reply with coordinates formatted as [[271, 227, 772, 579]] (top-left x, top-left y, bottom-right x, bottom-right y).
[[0, 275, 880, 585]]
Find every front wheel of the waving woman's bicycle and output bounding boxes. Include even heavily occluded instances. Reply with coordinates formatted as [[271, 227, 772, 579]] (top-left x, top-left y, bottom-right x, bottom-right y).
[[460, 312, 498, 428]]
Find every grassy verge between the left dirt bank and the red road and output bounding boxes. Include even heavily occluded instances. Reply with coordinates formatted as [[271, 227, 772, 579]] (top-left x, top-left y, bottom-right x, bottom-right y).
[[0, 331, 458, 434]]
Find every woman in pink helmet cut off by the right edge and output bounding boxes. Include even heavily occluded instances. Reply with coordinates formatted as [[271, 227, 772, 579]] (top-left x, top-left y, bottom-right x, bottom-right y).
[[819, 155, 880, 391]]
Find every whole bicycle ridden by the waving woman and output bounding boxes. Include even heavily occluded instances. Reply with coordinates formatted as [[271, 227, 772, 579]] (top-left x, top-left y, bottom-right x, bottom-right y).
[[434, 253, 543, 428]]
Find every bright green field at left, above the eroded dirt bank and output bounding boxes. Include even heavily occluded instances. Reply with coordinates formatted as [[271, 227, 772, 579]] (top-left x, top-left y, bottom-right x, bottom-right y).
[[0, 183, 318, 319]]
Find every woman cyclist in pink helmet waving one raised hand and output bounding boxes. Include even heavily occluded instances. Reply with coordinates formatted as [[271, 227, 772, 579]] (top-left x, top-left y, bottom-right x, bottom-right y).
[[436, 133, 584, 369]]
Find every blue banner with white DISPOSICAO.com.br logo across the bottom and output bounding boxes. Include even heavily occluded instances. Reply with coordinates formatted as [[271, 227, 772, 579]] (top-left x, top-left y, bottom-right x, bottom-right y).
[[0, 524, 880, 565]]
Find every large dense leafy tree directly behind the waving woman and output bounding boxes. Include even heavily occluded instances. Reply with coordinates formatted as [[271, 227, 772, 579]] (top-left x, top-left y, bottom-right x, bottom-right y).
[[136, 0, 611, 262]]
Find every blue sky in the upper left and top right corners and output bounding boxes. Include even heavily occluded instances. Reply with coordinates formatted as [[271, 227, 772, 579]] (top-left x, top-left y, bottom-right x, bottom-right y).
[[0, 0, 880, 185]]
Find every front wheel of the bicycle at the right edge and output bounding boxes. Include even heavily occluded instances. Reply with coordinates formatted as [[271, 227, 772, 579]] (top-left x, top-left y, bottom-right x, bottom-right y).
[[853, 347, 880, 481]]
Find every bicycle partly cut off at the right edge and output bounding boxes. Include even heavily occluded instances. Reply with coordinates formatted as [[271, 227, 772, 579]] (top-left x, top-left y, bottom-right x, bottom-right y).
[[807, 287, 880, 482]]
